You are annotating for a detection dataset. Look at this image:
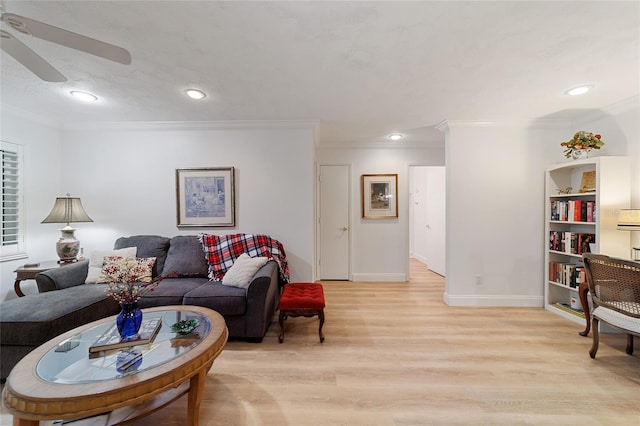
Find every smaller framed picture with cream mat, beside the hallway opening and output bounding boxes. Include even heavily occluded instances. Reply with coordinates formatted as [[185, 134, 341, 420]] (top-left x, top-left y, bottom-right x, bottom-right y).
[[362, 174, 398, 219]]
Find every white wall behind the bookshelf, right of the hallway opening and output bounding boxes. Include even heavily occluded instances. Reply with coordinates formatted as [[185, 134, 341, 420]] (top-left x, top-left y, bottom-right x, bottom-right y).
[[444, 98, 640, 306]]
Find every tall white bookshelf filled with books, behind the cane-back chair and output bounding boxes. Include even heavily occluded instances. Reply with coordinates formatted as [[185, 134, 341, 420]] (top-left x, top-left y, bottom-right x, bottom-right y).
[[544, 157, 631, 324]]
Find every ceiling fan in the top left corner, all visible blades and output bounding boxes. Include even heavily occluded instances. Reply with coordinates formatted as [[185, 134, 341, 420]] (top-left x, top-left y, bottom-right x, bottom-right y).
[[0, 2, 131, 82]]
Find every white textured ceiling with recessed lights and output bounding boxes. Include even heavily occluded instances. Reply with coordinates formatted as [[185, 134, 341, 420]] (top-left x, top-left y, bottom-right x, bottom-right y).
[[0, 0, 640, 145]]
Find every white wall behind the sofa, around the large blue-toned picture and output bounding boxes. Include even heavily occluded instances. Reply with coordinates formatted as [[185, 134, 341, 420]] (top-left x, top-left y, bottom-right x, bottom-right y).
[[61, 123, 315, 281]]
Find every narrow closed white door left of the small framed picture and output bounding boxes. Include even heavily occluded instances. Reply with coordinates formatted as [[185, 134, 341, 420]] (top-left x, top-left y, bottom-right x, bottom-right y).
[[318, 165, 351, 280]]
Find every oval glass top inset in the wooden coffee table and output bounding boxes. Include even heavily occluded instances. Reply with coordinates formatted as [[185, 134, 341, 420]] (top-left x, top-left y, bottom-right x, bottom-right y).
[[36, 308, 212, 384]]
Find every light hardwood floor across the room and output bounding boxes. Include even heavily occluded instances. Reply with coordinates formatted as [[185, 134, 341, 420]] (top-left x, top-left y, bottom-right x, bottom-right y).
[[0, 261, 640, 426]]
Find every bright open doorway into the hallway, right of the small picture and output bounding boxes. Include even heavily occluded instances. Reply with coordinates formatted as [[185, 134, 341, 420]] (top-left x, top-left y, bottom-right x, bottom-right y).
[[409, 166, 446, 276]]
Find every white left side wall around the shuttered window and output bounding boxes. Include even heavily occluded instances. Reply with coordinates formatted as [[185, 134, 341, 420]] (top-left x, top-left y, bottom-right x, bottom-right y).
[[0, 106, 62, 300]]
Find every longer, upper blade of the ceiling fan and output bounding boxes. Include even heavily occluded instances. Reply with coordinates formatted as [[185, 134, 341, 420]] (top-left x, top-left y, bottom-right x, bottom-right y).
[[2, 13, 131, 65]]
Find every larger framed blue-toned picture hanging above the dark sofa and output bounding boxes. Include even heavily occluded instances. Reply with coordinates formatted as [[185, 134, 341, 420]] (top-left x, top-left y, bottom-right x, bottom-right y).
[[176, 167, 236, 228]]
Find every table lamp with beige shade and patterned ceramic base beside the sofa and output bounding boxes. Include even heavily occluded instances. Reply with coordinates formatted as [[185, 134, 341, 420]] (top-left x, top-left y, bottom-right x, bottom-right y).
[[42, 194, 93, 263]]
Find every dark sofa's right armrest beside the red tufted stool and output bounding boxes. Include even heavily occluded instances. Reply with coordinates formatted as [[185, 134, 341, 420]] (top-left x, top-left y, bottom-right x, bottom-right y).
[[245, 261, 280, 340]]
